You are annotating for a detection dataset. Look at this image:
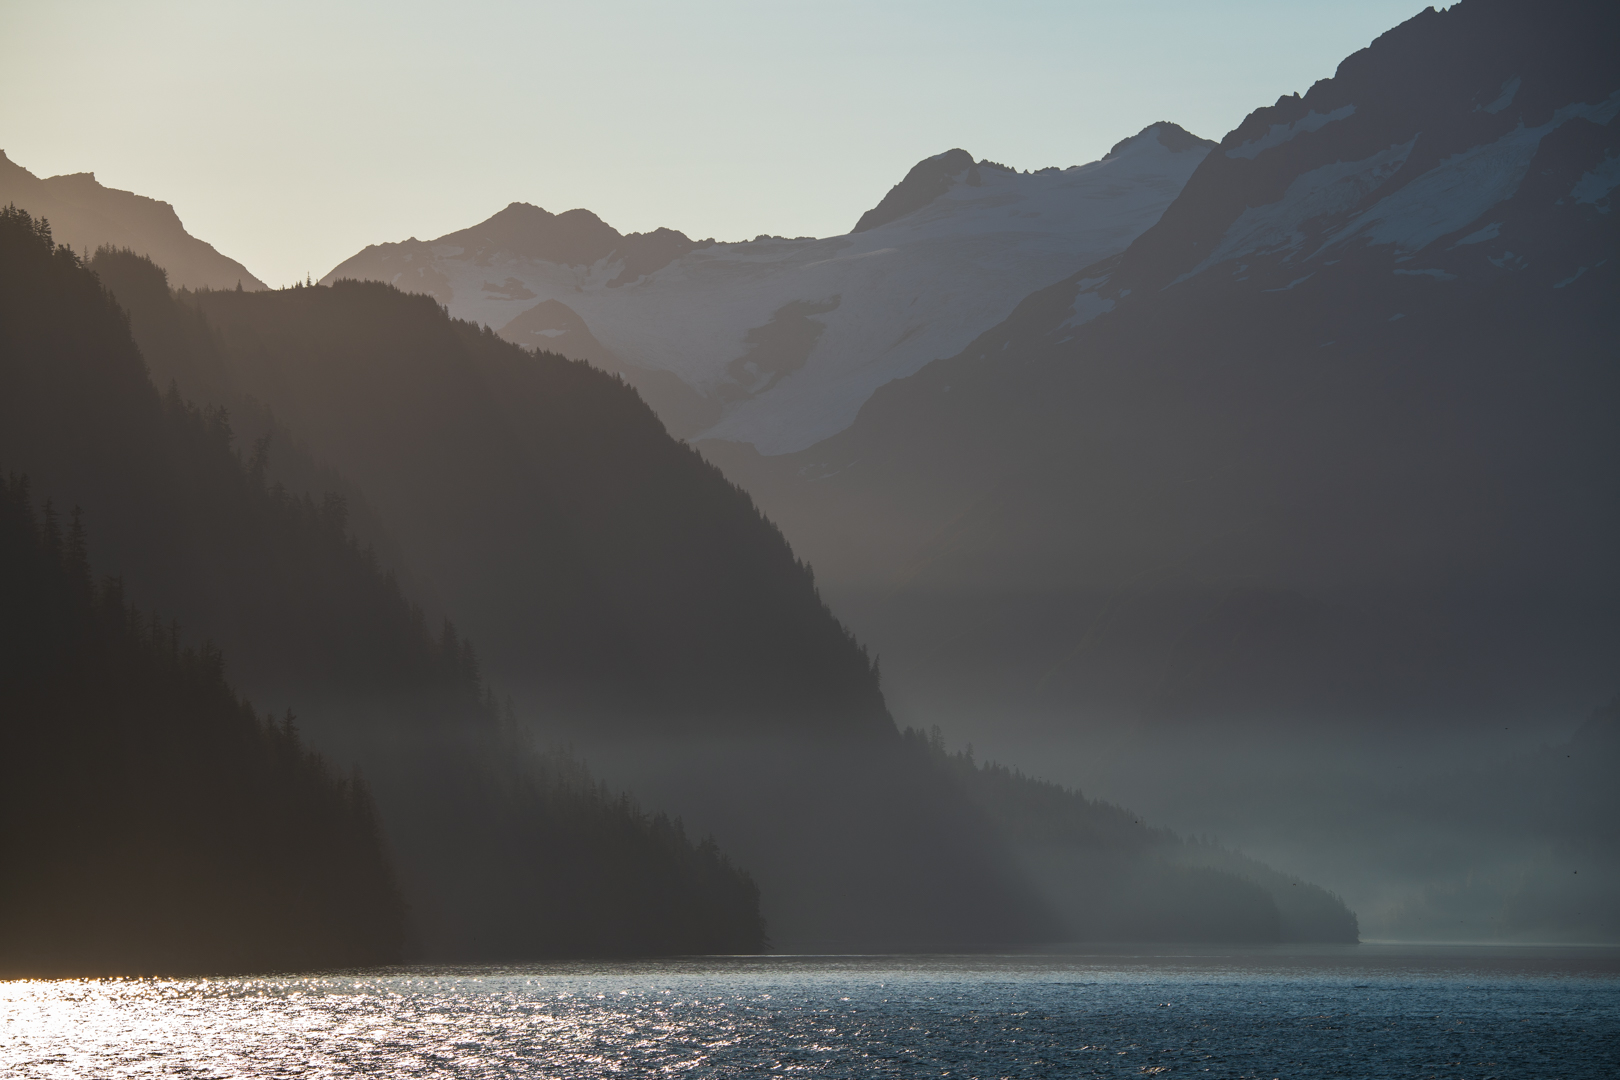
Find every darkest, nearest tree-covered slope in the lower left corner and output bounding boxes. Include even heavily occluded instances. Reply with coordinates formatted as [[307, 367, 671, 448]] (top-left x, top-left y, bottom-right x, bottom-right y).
[[0, 478, 407, 976]]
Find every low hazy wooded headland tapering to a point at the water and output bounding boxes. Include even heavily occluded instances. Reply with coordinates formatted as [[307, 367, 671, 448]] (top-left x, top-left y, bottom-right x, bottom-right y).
[[904, 727, 1359, 942]]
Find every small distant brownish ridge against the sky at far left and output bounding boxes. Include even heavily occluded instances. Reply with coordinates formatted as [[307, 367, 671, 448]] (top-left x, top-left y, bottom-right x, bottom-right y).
[[0, 151, 264, 288]]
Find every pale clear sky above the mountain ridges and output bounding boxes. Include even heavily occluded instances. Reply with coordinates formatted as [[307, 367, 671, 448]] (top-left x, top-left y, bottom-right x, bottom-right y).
[[0, 0, 1424, 285]]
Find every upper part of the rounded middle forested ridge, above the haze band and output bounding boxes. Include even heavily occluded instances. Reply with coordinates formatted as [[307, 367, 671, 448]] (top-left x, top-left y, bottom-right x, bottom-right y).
[[190, 282, 893, 733]]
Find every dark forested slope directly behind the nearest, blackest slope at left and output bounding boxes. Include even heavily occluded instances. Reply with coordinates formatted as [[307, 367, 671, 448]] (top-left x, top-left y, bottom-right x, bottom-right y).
[[0, 209, 765, 970]]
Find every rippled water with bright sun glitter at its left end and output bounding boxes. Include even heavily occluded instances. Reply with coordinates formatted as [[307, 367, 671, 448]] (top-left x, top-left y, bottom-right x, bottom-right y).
[[0, 946, 1620, 1080]]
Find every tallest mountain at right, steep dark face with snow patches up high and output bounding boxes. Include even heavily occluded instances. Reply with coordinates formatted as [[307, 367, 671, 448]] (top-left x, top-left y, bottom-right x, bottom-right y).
[[700, 0, 1620, 926]]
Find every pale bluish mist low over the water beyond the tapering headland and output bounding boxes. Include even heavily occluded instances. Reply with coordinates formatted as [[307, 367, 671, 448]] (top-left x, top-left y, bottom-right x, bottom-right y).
[[901, 704, 1620, 942]]
